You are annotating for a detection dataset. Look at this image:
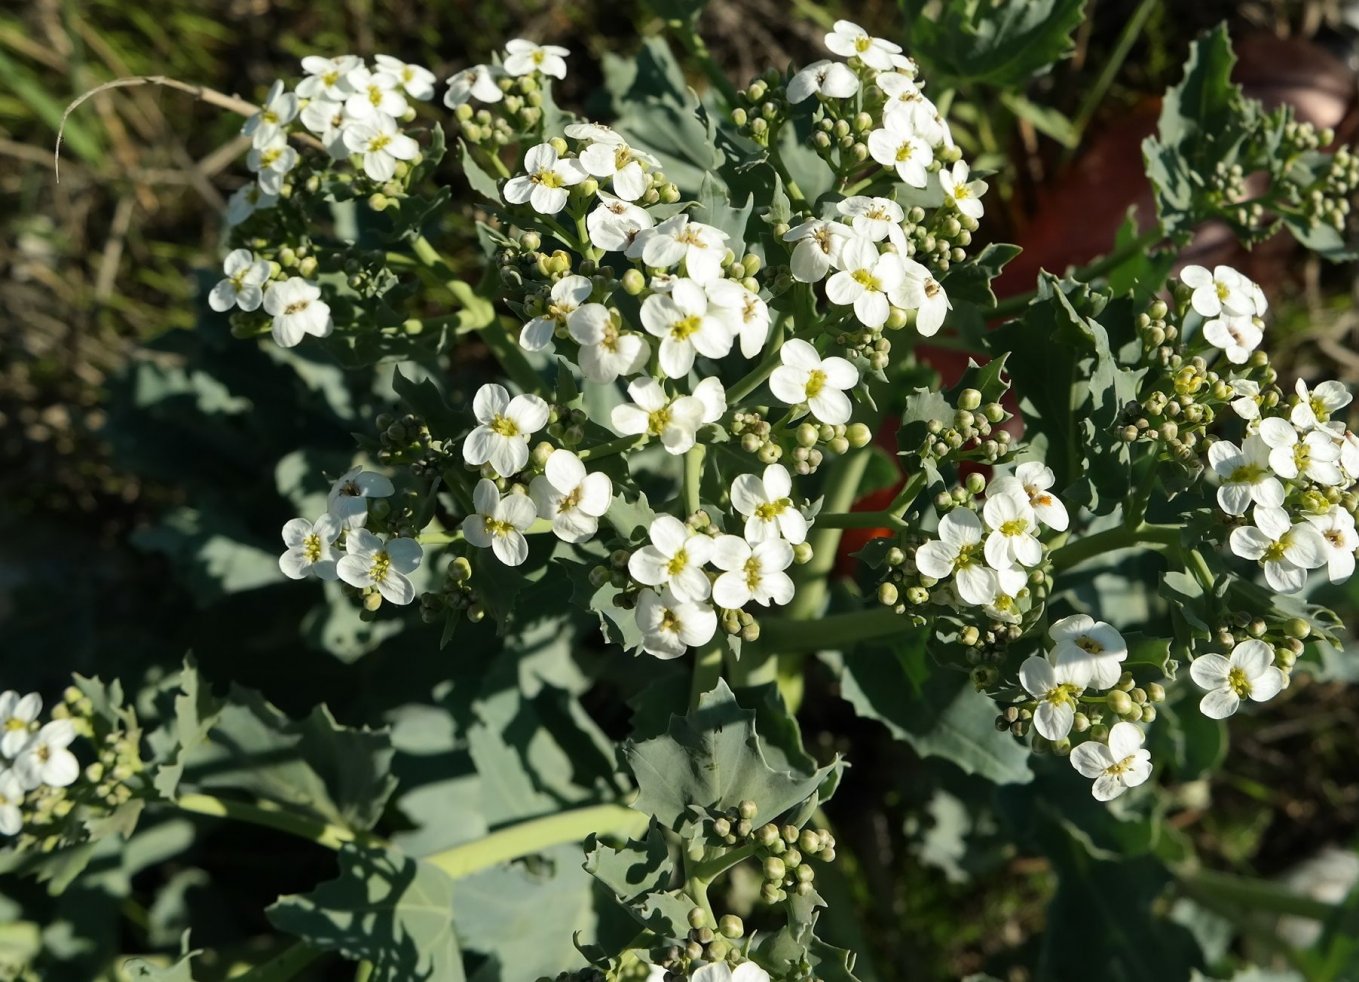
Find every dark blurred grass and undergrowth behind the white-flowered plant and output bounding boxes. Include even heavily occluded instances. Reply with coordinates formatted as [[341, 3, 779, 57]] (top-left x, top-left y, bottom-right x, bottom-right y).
[[0, 0, 1359, 979]]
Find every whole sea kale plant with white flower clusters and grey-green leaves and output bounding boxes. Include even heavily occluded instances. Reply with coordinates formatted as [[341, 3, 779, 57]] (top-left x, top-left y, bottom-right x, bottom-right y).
[[0, 4, 1359, 982]]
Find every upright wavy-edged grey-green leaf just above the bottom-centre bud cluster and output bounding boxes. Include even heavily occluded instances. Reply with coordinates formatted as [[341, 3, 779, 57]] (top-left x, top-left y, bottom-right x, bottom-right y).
[[622, 680, 844, 830]]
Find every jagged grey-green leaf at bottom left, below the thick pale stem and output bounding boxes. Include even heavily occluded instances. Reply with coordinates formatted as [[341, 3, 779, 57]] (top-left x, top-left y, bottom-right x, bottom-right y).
[[265, 843, 466, 982]]
